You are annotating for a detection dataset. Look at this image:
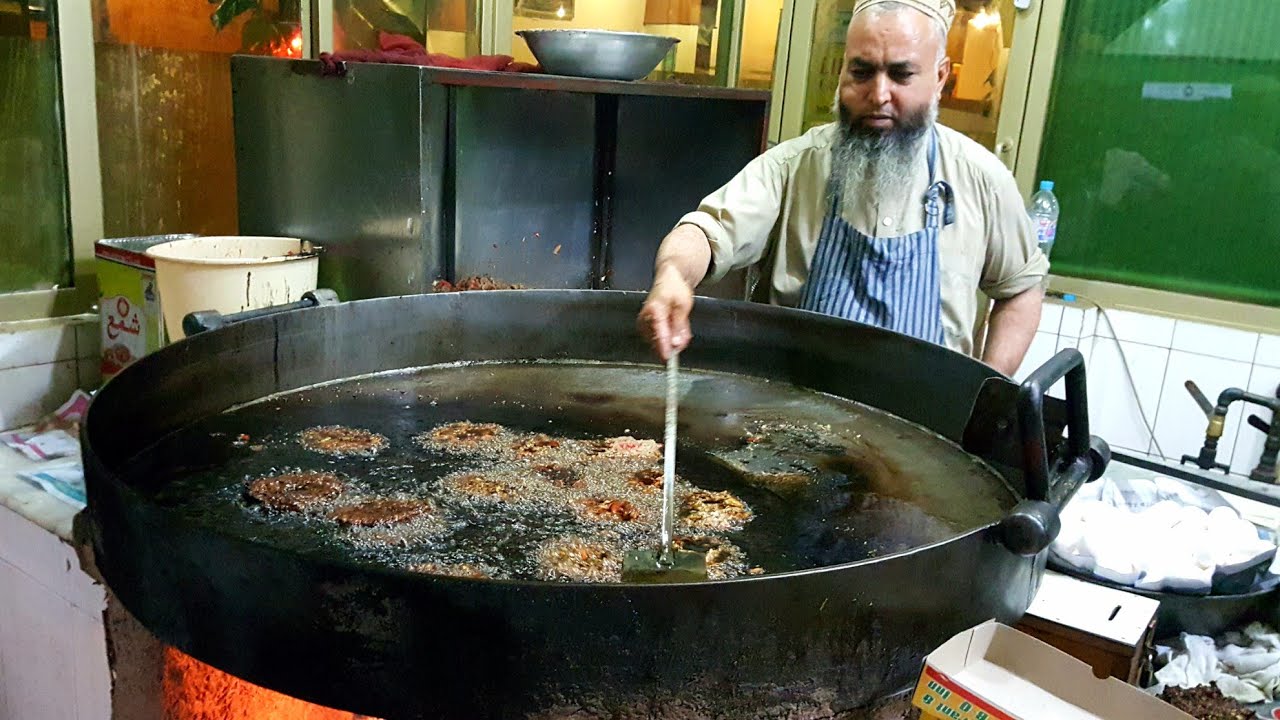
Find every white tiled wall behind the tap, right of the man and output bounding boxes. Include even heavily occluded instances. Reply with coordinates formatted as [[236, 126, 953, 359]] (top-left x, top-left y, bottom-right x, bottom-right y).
[[1016, 301, 1280, 474]]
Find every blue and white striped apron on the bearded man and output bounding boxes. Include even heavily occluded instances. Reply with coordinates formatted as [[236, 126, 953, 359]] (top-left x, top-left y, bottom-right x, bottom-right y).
[[800, 129, 955, 345]]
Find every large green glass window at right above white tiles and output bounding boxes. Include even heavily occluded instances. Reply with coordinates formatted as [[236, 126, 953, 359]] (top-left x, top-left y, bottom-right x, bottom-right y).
[[1038, 0, 1280, 305]]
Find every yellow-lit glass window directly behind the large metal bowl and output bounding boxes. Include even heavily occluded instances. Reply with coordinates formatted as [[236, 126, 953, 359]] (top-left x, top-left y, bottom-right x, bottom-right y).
[[512, 0, 742, 86]]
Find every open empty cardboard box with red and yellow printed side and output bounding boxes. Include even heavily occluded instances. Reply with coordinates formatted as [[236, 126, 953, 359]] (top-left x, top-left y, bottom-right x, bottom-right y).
[[913, 621, 1194, 720]]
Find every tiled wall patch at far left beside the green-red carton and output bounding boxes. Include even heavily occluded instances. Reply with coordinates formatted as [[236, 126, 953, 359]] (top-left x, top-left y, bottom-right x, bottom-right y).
[[0, 315, 101, 429]]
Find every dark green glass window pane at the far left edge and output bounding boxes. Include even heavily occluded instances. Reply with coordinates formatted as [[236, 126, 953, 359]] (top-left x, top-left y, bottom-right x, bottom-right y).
[[0, 0, 72, 292]]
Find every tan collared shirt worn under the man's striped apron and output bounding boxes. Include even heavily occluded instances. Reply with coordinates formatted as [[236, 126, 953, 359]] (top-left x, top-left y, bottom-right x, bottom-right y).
[[680, 123, 1048, 355]]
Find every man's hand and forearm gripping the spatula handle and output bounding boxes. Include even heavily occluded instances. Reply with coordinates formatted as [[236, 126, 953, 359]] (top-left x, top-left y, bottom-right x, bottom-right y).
[[636, 224, 712, 361]]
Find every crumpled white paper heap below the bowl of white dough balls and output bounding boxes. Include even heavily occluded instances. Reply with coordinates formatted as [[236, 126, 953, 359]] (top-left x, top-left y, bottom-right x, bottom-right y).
[[1156, 623, 1280, 705]]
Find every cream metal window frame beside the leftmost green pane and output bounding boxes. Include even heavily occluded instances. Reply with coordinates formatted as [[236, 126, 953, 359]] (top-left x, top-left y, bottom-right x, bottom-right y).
[[0, 1, 102, 322]]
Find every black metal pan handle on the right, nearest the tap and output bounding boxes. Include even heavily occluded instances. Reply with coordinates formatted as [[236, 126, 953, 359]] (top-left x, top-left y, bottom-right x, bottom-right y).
[[1000, 348, 1111, 556]]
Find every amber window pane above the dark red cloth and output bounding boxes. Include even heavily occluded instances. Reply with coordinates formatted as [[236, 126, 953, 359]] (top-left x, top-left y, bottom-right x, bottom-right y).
[[333, 0, 480, 58]]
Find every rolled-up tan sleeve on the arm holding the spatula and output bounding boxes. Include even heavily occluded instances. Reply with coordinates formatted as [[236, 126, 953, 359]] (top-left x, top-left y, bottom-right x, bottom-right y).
[[677, 152, 787, 284]]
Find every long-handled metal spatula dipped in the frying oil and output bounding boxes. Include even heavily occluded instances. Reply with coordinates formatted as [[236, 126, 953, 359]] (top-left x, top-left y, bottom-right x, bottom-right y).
[[622, 354, 707, 583]]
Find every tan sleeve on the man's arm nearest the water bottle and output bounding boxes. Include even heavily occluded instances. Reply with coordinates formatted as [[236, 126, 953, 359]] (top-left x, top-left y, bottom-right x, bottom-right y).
[[979, 173, 1048, 300]]
